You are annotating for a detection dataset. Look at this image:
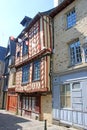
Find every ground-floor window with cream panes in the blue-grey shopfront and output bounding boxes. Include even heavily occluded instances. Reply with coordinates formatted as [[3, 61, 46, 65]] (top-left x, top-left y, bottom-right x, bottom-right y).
[[60, 84, 71, 108]]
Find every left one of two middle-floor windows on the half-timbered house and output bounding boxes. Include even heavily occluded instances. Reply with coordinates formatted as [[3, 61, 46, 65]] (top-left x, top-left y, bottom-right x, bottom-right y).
[[22, 64, 30, 83]]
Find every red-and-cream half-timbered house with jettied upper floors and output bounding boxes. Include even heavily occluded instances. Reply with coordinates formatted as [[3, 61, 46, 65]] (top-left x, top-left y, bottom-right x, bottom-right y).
[[15, 11, 52, 122]]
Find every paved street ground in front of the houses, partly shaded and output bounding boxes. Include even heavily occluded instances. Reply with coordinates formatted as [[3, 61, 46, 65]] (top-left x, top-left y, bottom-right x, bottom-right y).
[[0, 110, 76, 130]]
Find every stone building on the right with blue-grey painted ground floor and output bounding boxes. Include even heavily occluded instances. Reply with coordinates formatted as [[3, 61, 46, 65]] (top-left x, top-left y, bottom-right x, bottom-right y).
[[50, 0, 87, 129]]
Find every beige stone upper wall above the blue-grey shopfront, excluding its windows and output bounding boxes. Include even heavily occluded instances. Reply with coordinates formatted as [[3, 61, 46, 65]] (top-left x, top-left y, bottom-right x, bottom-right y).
[[53, 0, 87, 73]]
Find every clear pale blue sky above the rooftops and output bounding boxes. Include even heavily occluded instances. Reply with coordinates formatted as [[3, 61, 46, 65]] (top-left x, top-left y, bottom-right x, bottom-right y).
[[0, 0, 54, 47]]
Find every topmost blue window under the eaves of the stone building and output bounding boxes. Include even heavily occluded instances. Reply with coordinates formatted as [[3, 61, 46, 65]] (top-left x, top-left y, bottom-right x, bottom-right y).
[[67, 8, 76, 28]]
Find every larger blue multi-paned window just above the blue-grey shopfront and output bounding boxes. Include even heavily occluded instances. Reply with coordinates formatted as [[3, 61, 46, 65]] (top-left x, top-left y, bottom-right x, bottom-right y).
[[70, 41, 82, 65]]
